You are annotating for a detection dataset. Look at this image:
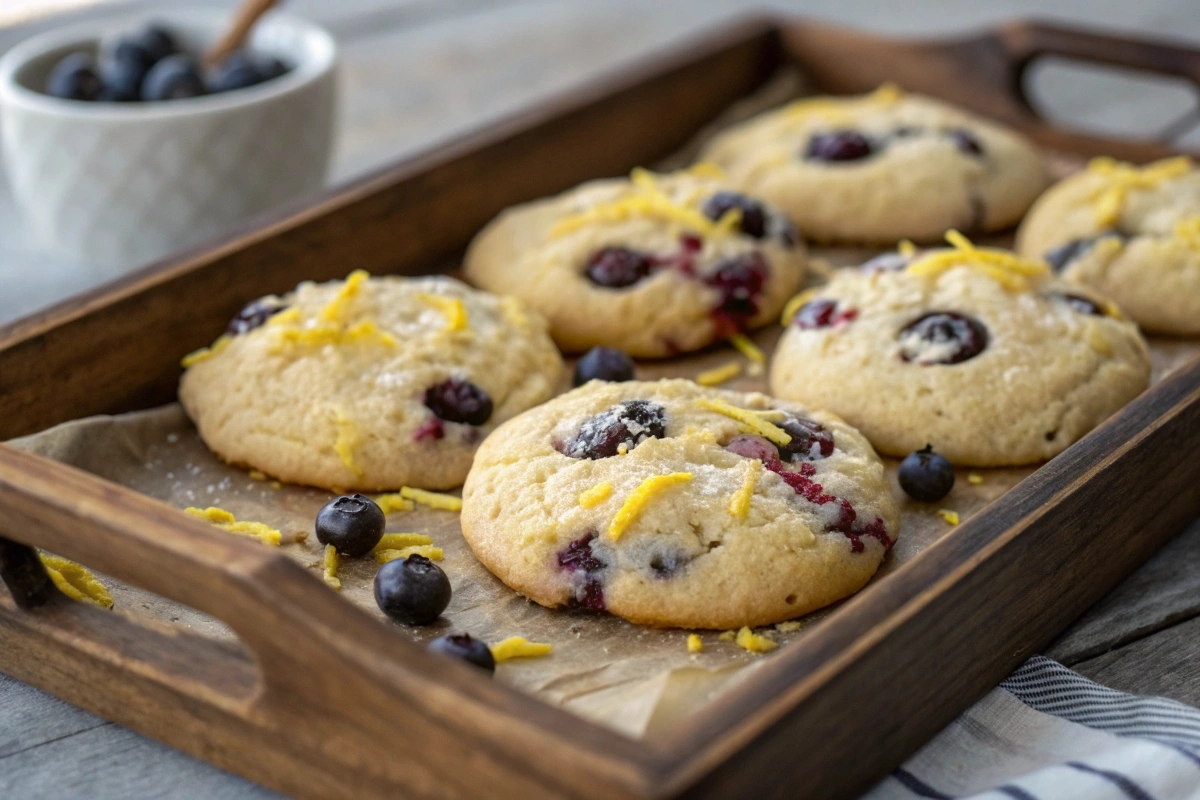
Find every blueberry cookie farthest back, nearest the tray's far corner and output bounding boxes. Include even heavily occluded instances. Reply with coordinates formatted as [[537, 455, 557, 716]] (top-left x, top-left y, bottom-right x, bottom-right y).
[[702, 85, 1049, 246]]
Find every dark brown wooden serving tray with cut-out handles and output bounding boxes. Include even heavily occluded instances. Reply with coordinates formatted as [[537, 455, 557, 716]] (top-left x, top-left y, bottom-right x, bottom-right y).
[[0, 14, 1200, 798]]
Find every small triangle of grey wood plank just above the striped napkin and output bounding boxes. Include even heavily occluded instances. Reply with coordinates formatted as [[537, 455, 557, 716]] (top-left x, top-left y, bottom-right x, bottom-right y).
[[1074, 619, 1200, 705]]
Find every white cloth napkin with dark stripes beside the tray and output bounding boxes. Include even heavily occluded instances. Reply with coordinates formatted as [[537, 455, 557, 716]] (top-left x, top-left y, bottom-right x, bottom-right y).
[[864, 656, 1200, 800]]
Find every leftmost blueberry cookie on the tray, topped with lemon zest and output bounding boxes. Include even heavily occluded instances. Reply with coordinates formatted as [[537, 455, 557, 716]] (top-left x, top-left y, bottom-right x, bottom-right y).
[[179, 271, 563, 491]]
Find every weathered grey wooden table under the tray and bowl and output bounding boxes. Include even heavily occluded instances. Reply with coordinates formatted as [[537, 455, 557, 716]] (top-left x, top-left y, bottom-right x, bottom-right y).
[[0, 0, 1200, 800]]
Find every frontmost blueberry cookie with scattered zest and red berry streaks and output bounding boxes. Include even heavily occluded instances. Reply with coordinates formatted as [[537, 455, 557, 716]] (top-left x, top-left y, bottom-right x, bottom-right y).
[[462, 380, 900, 628]]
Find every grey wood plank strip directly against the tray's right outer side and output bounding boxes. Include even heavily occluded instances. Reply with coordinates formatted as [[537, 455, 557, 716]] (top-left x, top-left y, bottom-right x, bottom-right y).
[[1045, 521, 1200, 667]]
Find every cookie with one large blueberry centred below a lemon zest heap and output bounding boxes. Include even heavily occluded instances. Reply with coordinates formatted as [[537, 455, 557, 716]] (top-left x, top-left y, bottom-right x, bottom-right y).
[[770, 231, 1150, 467]]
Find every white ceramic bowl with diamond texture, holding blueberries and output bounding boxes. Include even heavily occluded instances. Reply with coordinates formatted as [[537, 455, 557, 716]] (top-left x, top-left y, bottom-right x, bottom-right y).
[[0, 8, 337, 277]]
